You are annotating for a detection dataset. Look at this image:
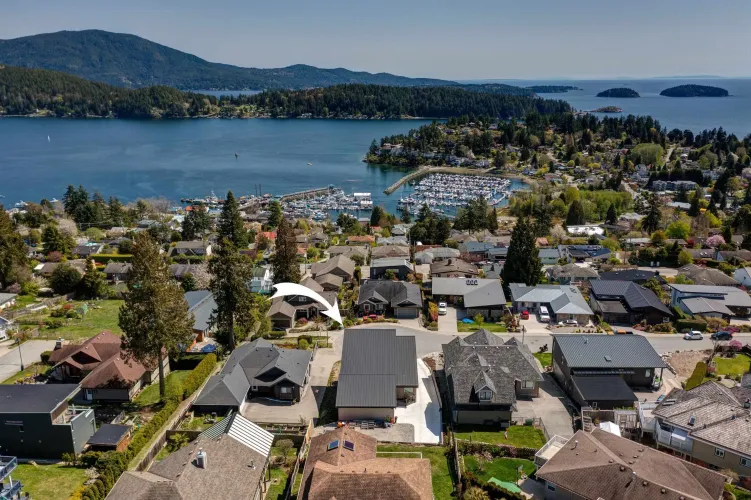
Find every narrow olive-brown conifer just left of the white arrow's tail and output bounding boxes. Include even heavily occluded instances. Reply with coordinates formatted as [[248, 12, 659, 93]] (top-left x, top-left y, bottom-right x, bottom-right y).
[[209, 239, 255, 352]]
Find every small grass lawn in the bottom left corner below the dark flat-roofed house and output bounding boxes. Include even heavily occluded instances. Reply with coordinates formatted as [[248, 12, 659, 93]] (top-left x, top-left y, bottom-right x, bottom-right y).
[[12, 464, 86, 500]]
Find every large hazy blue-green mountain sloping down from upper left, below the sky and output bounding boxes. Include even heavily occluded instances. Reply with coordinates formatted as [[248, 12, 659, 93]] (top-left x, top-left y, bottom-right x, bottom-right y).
[[0, 30, 456, 90]]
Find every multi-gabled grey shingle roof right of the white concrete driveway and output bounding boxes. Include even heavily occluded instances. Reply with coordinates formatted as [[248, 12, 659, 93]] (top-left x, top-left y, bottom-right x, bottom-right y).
[[443, 329, 542, 405]]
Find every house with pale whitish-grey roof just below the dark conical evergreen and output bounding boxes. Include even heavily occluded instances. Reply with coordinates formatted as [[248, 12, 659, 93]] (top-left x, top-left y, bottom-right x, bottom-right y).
[[509, 283, 594, 325]]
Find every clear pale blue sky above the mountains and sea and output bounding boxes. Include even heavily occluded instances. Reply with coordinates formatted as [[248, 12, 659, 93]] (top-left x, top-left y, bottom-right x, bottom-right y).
[[0, 0, 751, 80]]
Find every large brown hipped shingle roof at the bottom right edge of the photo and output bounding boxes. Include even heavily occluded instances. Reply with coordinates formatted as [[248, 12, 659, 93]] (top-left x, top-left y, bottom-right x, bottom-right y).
[[536, 429, 725, 500]]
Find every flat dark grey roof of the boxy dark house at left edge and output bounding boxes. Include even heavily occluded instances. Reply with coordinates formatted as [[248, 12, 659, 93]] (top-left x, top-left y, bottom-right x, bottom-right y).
[[0, 384, 78, 414]]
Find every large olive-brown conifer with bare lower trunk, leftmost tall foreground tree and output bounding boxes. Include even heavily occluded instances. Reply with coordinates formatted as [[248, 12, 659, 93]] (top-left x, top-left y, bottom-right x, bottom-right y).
[[118, 232, 194, 400]]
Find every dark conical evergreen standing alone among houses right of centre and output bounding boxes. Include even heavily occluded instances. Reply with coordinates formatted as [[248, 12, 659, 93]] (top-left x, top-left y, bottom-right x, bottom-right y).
[[501, 217, 542, 296]]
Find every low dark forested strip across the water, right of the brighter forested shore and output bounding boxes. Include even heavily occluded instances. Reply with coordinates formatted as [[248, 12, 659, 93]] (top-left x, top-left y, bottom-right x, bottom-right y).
[[226, 84, 571, 119]]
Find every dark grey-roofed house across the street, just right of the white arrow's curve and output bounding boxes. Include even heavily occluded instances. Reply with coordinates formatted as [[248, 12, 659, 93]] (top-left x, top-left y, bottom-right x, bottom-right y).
[[357, 280, 422, 319]]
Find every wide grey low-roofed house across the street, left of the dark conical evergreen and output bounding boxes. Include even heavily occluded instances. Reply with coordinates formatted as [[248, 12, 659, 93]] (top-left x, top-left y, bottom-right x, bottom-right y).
[[432, 278, 506, 319]]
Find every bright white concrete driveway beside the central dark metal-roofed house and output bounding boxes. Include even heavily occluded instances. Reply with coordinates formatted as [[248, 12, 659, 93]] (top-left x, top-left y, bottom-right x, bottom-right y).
[[394, 359, 441, 444]]
